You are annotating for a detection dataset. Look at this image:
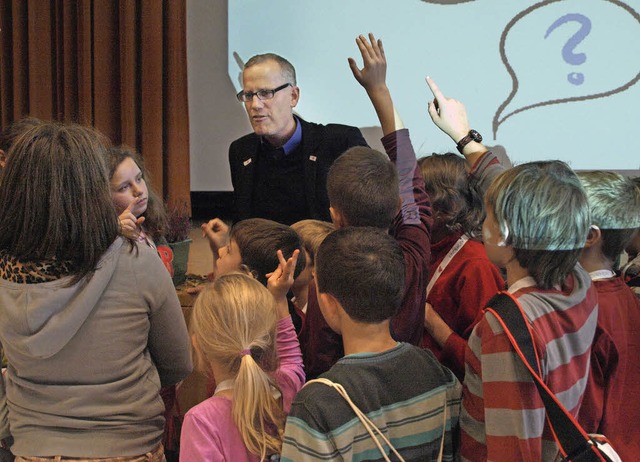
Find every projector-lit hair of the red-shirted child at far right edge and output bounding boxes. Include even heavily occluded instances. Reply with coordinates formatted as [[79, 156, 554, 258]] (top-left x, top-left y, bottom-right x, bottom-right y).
[[578, 171, 640, 262]]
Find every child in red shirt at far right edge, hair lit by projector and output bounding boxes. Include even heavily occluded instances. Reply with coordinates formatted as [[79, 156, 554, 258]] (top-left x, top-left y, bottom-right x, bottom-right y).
[[578, 171, 640, 460]]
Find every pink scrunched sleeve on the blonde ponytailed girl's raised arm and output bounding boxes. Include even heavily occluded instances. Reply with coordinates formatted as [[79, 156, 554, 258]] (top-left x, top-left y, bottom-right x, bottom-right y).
[[275, 316, 305, 413]]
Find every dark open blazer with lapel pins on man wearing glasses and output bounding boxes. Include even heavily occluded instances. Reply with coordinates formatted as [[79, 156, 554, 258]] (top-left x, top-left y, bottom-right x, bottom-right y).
[[229, 118, 367, 221]]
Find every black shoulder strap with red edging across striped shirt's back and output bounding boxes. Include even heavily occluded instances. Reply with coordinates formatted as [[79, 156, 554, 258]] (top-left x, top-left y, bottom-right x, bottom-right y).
[[486, 292, 607, 461]]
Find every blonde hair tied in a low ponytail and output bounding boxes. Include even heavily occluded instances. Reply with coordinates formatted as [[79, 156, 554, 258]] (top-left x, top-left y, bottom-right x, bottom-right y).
[[191, 273, 285, 460]]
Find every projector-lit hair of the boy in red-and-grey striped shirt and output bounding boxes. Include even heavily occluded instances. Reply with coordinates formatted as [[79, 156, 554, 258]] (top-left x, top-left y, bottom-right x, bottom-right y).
[[485, 161, 591, 289]]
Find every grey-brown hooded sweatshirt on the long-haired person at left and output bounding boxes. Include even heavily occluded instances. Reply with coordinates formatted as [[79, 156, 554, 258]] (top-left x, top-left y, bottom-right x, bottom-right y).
[[0, 238, 191, 458]]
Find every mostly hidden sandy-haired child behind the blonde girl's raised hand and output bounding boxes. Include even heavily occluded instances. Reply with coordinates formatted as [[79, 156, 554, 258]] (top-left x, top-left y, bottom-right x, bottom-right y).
[[291, 219, 335, 313]]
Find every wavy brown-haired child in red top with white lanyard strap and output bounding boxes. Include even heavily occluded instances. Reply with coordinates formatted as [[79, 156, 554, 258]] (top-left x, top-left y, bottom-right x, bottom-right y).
[[418, 153, 505, 380]]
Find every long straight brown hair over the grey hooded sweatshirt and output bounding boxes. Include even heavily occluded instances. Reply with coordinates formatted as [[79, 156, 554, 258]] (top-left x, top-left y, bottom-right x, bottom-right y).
[[0, 123, 118, 283]]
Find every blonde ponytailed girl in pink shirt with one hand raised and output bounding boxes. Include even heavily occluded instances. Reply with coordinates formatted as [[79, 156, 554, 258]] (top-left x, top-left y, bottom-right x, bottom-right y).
[[180, 250, 304, 462]]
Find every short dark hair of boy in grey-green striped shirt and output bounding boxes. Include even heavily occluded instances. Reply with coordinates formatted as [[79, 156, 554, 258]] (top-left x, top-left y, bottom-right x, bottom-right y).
[[316, 226, 405, 324]]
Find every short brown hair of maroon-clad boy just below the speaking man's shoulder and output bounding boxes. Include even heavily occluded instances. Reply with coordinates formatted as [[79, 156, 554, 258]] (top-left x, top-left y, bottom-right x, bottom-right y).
[[327, 146, 400, 229]]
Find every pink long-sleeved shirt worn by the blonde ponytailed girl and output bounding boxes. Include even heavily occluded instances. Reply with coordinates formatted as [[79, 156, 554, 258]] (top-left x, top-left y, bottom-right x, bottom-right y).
[[180, 317, 305, 462]]
